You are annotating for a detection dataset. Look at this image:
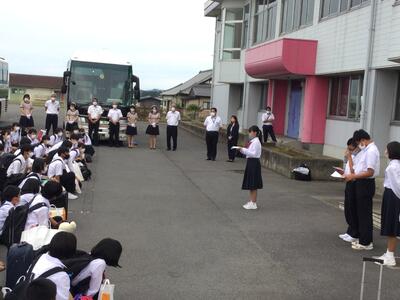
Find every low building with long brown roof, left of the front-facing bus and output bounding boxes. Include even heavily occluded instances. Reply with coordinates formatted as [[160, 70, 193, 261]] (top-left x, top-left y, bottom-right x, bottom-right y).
[[9, 73, 63, 102]]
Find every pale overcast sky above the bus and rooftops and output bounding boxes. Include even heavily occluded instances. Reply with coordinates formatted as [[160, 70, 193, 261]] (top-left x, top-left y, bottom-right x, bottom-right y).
[[0, 0, 215, 89]]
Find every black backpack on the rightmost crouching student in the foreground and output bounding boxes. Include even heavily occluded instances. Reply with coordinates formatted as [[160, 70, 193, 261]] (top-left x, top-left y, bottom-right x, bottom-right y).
[[62, 250, 95, 296]]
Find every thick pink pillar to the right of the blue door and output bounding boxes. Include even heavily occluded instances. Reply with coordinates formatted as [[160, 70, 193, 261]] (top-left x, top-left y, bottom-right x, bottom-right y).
[[301, 76, 329, 144]]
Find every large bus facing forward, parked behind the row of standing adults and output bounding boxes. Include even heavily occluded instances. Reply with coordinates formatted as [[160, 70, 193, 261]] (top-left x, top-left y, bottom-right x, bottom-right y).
[[61, 53, 140, 140]]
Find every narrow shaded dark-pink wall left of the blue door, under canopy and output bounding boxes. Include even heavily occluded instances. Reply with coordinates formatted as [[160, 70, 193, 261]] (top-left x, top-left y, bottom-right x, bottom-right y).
[[268, 80, 288, 135]]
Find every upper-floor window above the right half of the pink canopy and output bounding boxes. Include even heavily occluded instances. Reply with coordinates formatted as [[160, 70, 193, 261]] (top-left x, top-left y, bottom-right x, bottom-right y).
[[281, 0, 314, 33]]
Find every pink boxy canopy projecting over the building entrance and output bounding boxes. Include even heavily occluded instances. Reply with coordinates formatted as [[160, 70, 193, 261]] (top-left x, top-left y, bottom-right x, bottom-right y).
[[245, 38, 318, 78]]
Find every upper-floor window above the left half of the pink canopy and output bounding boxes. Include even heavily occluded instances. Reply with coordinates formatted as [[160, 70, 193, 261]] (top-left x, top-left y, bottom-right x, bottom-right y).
[[253, 0, 277, 44]]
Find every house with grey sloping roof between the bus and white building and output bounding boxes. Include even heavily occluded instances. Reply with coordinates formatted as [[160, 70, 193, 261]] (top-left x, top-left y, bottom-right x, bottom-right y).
[[161, 70, 212, 110]]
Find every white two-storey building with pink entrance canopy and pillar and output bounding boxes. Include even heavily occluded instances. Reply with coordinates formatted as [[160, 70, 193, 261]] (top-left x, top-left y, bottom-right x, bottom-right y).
[[205, 0, 400, 158]]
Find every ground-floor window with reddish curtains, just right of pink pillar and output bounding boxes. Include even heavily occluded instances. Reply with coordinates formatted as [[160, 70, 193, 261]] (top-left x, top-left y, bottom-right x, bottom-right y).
[[329, 75, 364, 120]]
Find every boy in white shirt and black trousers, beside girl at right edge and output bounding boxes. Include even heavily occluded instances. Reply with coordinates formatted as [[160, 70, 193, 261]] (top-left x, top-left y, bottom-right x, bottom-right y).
[[345, 129, 380, 250]]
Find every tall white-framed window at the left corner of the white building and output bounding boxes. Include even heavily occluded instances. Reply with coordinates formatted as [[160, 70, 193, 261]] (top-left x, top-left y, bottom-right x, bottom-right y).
[[221, 8, 243, 60]]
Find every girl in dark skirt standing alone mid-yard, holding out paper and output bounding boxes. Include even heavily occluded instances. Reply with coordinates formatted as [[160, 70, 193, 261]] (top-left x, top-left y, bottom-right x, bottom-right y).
[[239, 125, 263, 209]]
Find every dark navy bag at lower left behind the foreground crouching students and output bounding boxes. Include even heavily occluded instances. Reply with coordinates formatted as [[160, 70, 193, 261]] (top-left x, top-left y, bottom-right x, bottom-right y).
[[6, 243, 34, 289]]
